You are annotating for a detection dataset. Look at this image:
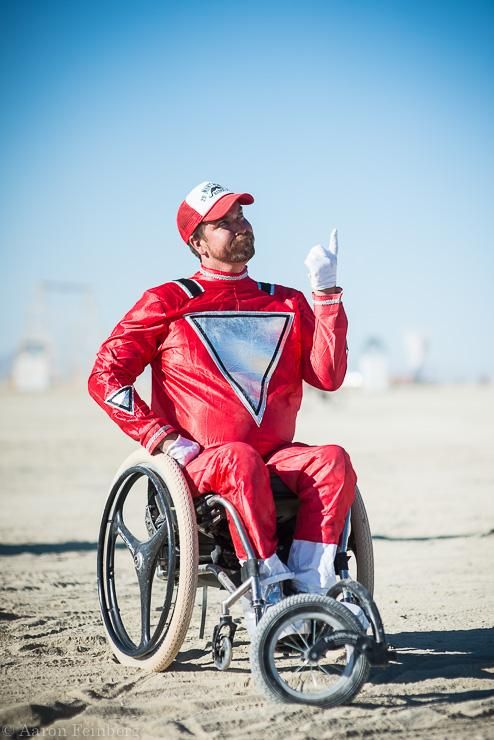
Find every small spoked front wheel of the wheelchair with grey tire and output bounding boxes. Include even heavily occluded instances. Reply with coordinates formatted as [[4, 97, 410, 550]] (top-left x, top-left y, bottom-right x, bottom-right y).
[[251, 594, 370, 707]]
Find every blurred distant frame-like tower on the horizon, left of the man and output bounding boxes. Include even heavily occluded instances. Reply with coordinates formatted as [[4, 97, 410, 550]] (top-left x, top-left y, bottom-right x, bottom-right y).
[[11, 280, 97, 392]]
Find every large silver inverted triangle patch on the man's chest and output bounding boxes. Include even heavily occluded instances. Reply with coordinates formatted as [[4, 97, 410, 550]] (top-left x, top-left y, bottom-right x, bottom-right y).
[[185, 311, 294, 426]]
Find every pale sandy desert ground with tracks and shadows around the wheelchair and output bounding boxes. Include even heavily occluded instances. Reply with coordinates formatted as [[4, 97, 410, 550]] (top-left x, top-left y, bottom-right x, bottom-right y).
[[0, 386, 494, 740]]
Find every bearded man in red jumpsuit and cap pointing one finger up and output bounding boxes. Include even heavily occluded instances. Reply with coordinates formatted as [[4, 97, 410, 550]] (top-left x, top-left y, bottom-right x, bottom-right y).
[[89, 182, 356, 604]]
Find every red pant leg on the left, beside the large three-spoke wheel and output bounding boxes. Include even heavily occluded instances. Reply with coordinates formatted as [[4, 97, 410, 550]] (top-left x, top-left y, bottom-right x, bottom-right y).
[[184, 442, 277, 559]]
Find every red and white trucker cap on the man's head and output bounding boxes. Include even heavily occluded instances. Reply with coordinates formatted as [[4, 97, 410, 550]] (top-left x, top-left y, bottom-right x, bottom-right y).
[[177, 181, 254, 244]]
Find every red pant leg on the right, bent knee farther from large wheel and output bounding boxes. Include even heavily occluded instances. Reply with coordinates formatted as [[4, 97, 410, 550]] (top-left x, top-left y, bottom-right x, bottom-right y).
[[266, 444, 357, 544]]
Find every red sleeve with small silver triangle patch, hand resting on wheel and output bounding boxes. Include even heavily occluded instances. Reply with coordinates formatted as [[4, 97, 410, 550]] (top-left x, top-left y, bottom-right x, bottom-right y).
[[88, 291, 175, 452]]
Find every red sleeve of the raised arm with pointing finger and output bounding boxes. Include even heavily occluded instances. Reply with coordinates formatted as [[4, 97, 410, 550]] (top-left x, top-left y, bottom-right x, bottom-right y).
[[300, 293, 348, 391]]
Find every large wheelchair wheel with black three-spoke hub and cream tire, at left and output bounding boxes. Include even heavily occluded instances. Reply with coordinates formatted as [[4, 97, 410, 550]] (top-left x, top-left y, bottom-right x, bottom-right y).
[[98, 450, 198, 671]]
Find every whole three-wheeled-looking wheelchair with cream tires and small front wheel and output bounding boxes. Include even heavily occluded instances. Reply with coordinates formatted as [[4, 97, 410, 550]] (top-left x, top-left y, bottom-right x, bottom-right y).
[[97, 449, 392, 707]]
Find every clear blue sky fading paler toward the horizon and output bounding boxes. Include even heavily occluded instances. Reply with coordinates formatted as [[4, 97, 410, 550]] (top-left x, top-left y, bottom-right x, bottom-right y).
[[0, 0, 494, 380]]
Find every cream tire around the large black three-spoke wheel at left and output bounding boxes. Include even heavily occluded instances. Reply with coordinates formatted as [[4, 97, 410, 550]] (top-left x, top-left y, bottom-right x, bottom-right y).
[[98, 449, 199, 672]]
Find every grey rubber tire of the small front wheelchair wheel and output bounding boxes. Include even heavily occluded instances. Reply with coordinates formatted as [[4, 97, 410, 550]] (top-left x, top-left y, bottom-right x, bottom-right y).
[[250, 594, 370, 708]]
